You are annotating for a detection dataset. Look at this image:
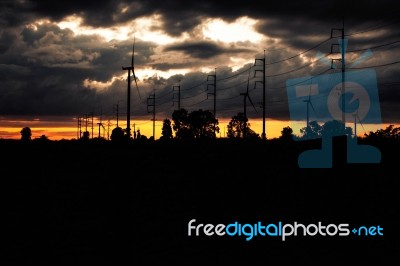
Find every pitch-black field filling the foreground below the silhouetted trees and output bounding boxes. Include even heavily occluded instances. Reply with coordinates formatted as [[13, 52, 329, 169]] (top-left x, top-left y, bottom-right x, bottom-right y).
[[0, 140, 400, 266]]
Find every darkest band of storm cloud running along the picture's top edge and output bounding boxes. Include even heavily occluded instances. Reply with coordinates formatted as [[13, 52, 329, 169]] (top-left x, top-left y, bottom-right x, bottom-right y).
[[2, 0, 399, 32]]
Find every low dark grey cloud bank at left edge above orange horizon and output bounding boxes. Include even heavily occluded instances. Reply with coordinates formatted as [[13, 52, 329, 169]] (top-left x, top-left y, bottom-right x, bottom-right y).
[[0, 65, 94, 115]]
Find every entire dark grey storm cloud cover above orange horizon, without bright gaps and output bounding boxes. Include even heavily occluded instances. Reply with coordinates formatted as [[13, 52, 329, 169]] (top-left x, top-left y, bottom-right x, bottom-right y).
[[0, 0, 400, 121]]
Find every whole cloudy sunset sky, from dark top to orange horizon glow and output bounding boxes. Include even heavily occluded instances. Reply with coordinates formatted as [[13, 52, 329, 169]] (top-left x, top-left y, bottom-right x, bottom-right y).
[[0, 0, 400, 138]]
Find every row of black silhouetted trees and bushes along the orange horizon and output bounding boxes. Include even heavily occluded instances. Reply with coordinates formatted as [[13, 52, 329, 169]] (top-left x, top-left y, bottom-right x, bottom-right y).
[[20, 108, 400, 142]]
